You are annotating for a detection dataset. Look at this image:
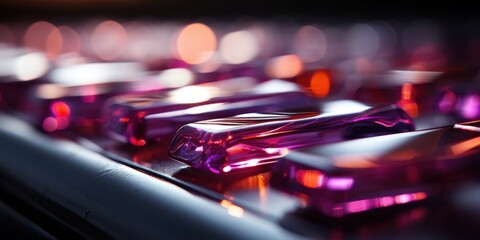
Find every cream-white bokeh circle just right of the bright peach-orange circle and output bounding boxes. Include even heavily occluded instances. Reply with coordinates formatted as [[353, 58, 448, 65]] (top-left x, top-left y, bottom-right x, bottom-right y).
[[220, 31, 260, 64]]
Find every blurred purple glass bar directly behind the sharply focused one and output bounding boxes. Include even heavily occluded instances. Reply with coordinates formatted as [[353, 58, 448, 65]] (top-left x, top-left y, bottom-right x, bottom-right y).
[[103, 77, 317, 146]]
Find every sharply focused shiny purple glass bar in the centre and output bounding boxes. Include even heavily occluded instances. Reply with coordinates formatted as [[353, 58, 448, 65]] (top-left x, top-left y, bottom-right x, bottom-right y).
[[169, 105, 415, 173]]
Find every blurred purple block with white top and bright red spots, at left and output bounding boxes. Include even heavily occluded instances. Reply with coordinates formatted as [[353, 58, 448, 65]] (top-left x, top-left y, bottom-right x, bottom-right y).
[[15, 62, 154, 132]]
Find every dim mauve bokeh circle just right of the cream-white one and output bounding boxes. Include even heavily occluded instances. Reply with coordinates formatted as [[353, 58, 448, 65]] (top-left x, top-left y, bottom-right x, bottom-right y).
[[293, 26, 327, 63]]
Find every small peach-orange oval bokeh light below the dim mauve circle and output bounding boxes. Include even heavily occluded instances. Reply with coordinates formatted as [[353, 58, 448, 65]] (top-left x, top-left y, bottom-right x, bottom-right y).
[[265, 55, 303, 78]]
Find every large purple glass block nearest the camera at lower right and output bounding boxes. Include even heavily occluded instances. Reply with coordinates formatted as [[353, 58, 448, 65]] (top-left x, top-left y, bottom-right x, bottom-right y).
[[271, 122, 480, 217]]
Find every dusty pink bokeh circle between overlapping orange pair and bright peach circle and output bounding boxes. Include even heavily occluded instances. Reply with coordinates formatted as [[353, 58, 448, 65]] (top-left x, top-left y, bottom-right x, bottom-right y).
[[92, 20, 128, 61]]
